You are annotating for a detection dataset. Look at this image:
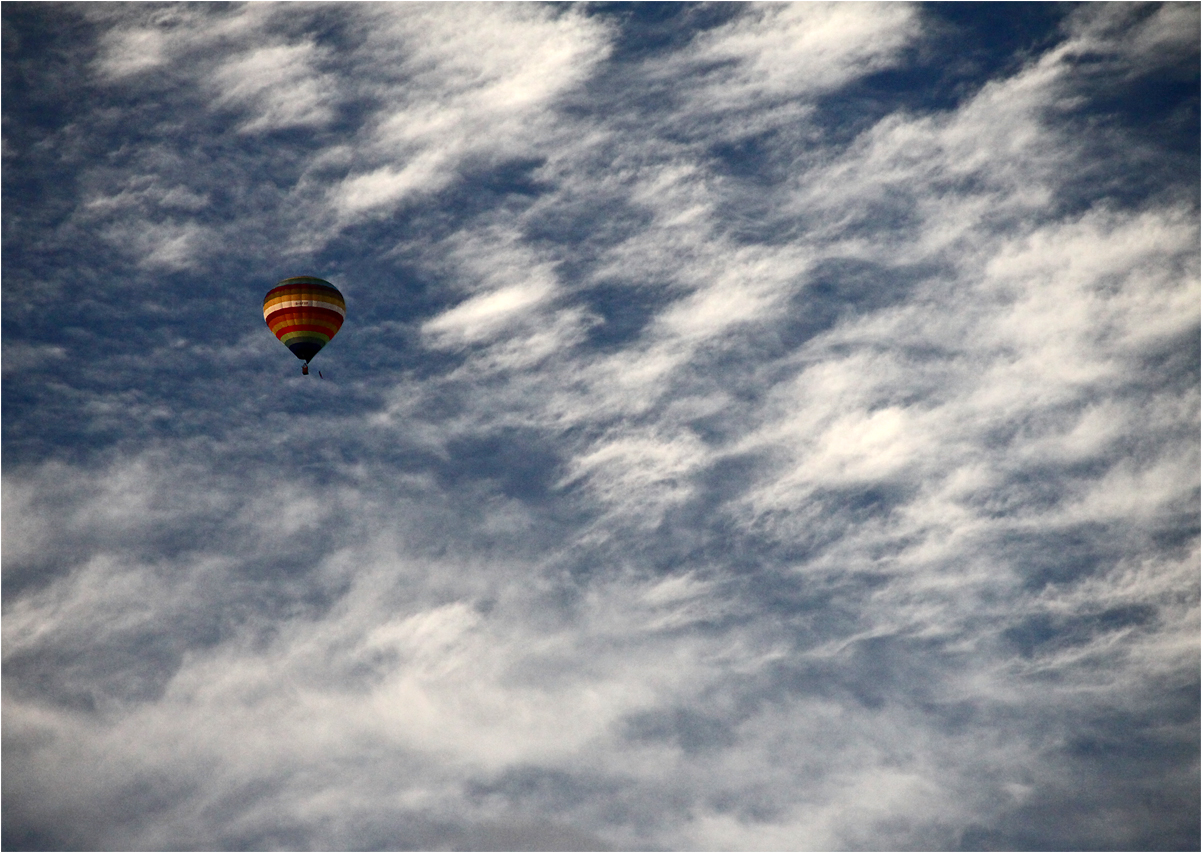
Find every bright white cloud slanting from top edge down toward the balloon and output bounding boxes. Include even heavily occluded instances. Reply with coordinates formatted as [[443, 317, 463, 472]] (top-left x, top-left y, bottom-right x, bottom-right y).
[[331, 5, 608, 223]]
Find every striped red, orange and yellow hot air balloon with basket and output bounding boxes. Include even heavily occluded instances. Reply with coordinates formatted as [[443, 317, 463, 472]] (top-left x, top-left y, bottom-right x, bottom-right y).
[[263, 275, 346, 376]]
